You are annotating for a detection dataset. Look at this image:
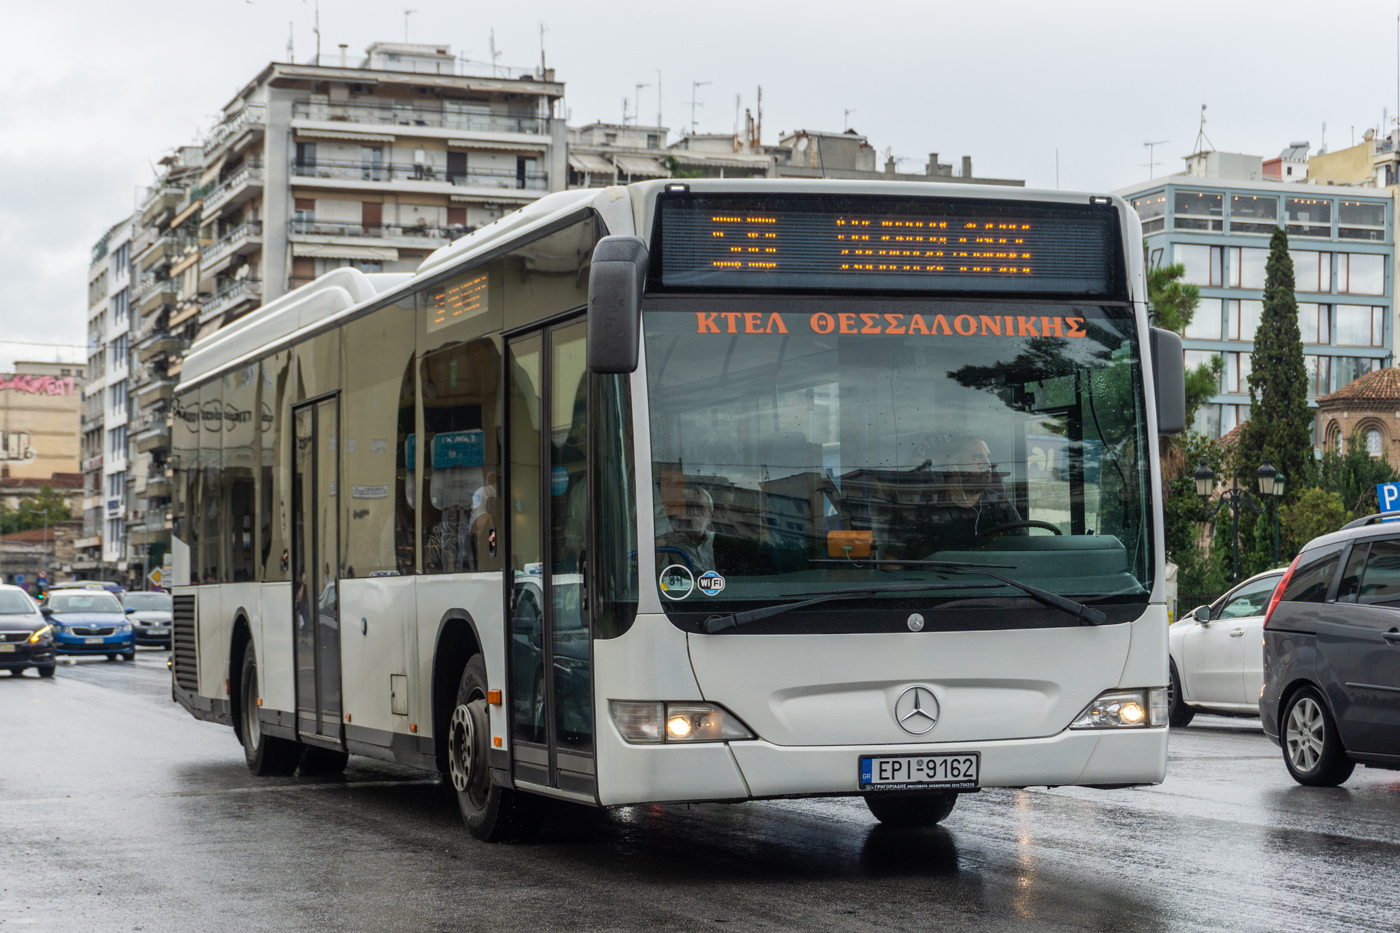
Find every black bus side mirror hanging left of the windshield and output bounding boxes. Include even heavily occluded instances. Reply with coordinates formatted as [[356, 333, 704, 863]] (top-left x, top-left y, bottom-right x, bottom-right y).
[[588, 237, 648, 373]]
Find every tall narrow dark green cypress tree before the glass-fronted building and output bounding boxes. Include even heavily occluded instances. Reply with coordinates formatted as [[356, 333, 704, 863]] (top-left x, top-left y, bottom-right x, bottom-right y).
[[1239, 227, 1315, 562]]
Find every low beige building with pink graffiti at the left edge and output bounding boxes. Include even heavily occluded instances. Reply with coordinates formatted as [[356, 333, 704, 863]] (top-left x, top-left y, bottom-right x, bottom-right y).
[[0, 363, 83, 479]]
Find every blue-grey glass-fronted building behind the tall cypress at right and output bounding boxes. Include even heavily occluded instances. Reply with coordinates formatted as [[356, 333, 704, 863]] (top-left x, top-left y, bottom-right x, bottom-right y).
[[1119, 154, 1394, 443]]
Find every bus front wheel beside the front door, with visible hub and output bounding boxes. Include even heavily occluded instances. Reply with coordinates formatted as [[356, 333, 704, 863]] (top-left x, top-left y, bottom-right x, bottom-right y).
[[447, 654, 545, 842]]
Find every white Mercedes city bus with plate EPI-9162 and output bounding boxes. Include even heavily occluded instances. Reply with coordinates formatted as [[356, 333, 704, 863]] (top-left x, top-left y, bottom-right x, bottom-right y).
[[172, 179, 1183, 839]]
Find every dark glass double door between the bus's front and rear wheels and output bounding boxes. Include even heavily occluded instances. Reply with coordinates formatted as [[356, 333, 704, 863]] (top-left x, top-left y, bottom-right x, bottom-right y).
[[291, 396, 343, 748]]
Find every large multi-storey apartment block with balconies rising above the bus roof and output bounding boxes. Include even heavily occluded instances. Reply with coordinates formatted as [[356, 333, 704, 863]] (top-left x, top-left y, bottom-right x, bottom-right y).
[[197, 42, 566, 323]]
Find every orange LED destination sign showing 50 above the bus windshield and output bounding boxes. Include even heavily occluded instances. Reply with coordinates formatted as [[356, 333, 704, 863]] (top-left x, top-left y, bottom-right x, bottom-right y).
[[658, 196, 1123, 296]]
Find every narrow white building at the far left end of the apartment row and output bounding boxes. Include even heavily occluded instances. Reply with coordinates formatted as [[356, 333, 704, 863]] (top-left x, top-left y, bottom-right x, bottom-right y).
[[73, 214, 139, 576]]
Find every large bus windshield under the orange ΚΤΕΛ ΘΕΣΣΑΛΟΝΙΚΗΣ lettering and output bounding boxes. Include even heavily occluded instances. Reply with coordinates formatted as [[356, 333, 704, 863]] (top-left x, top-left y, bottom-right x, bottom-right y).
[[644, 296, 1152, 630]]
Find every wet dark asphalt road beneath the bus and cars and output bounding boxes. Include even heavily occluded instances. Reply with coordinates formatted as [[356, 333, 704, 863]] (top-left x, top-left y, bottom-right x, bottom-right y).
[[0, 650, 1400, 933]]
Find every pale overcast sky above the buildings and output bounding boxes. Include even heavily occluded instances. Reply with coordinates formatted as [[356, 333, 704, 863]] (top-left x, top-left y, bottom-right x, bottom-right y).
[[0, 0, 1397, 371]]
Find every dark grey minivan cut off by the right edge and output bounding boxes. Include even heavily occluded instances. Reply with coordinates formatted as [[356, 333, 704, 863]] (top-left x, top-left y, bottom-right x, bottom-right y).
[[1259, 516, 1400, 787]]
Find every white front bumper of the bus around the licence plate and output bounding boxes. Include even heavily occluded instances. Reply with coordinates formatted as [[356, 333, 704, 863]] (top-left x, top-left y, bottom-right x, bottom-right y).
[[599, 727, 1168, 806]]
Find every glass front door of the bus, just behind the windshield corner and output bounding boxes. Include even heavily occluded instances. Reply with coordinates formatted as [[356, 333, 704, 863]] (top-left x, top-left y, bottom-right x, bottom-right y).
[[505, 319, 596, 800]]
